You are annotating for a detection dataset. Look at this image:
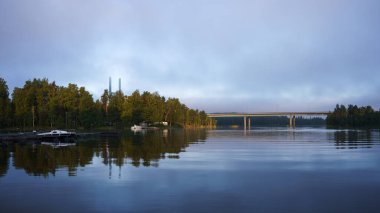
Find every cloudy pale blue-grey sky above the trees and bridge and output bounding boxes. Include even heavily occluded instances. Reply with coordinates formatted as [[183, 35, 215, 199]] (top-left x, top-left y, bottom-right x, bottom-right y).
[[0, 0, 380, 112]]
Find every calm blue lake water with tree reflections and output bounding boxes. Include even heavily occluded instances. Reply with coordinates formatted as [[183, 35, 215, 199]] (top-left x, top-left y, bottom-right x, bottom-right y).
[[0, 128, 380, 212]]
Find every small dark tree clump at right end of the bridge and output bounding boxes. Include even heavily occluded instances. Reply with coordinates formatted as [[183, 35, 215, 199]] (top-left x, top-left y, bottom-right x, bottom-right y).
[[326, 104, 380, 127]]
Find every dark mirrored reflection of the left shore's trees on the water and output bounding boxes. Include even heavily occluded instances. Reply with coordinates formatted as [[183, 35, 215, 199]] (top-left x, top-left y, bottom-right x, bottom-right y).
[[0, 130, 206, 177]]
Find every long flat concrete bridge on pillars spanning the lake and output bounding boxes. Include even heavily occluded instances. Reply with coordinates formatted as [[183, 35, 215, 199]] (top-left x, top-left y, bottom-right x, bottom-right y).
[[207, 112, 331, 129]]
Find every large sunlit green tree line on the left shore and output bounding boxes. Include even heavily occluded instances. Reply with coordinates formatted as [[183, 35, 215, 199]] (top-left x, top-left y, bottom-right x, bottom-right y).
[[0, 78, 214, 129]]
